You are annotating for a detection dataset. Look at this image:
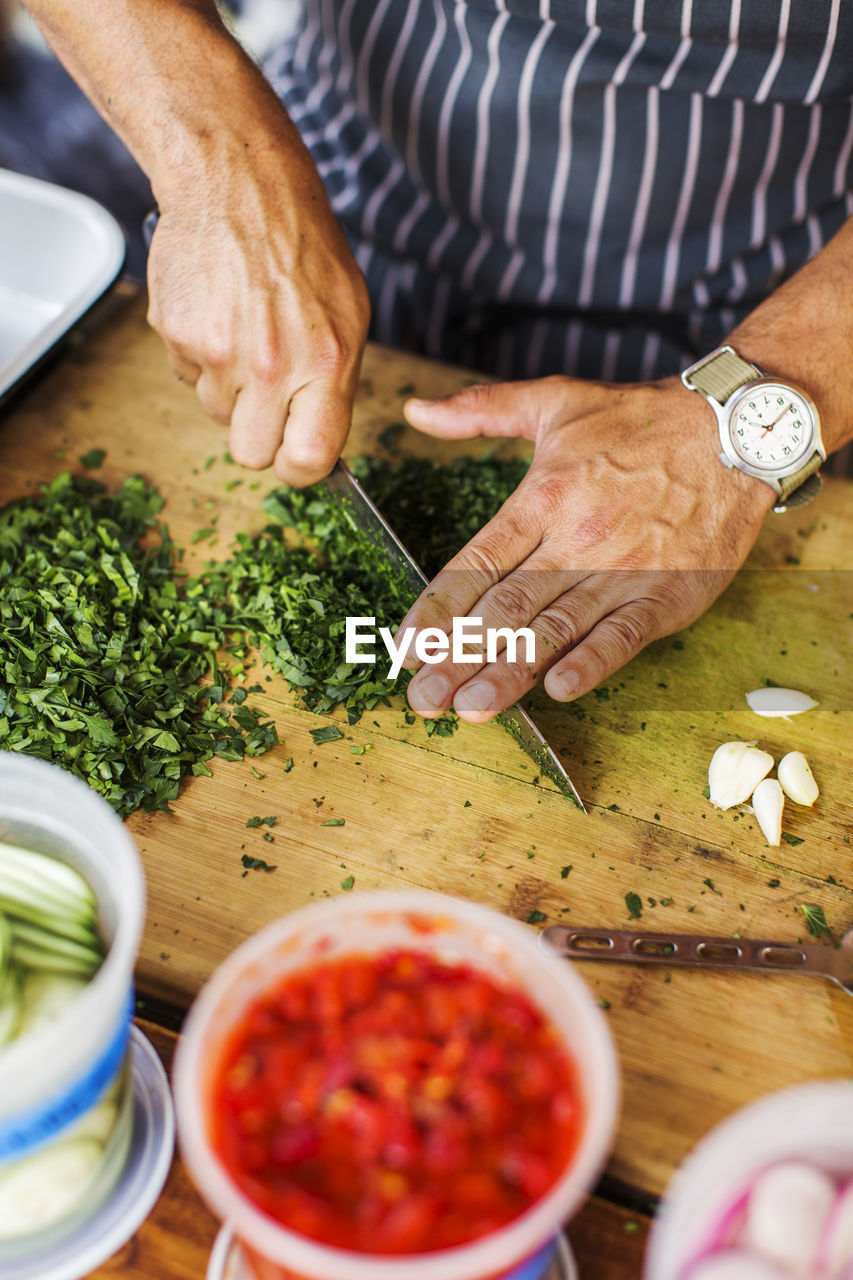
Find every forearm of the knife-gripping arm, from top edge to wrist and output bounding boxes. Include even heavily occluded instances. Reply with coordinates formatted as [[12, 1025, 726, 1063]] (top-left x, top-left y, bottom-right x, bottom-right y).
[[21, 0, 306, 202]]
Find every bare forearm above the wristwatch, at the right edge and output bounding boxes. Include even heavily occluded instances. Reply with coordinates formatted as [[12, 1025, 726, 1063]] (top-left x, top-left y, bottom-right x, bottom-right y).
[[730, 219, 853, 453]]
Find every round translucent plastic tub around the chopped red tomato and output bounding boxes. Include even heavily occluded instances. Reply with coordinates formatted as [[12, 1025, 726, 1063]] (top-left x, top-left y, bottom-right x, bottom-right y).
[[173, 891, 619, 1280]]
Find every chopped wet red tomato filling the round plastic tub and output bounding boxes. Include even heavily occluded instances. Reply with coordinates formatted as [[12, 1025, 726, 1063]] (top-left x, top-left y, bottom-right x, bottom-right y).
[[211, 951, 583, 1254]]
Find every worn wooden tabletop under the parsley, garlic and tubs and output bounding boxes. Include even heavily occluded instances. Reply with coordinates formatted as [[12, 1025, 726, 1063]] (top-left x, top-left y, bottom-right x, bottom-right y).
[[0, 293, 853, 1280]]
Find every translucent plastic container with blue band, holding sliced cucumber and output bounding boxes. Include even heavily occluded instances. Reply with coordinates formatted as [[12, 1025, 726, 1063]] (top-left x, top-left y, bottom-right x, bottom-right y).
[[0, 751, 145, 1276]]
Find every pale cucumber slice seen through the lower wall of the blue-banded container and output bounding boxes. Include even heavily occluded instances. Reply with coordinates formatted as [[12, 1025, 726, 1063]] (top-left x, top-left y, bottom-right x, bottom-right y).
[[0, 1138, 104, 1240]]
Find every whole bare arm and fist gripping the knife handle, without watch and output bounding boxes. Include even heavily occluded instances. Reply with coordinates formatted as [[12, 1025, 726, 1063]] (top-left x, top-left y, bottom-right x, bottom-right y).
[[27, 0, 369, 485]]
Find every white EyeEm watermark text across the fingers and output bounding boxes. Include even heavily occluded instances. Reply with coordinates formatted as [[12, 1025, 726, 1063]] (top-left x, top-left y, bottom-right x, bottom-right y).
[[345, 617, 537, 680]]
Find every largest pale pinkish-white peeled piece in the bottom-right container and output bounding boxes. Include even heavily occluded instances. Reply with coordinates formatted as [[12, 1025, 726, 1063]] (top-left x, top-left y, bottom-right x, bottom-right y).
[[742, 1161, 835, 1280]]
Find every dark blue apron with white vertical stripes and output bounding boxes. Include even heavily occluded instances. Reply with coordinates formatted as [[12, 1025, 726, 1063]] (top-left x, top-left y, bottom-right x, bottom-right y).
[[266, 0, 853, 380]]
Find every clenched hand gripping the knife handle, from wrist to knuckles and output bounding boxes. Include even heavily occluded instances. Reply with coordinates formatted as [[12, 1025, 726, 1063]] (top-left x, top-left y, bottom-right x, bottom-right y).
[[143, 131, 370, 485]]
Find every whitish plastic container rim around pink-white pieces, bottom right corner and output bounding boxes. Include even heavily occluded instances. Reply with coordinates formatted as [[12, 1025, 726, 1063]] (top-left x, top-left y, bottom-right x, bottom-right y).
[[644, 1080, 853, 1280]]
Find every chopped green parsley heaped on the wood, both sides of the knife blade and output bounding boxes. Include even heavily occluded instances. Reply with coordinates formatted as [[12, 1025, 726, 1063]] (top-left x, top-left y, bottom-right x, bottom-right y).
[[0, 458, 526, 815]]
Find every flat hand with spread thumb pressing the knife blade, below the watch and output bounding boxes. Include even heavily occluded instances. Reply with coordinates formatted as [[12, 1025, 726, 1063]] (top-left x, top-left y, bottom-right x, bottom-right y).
[[401, 376, 774, 723]]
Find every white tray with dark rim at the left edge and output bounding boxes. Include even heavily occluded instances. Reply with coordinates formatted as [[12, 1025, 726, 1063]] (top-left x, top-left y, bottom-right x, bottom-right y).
[[0, 169, 126, 404]]
